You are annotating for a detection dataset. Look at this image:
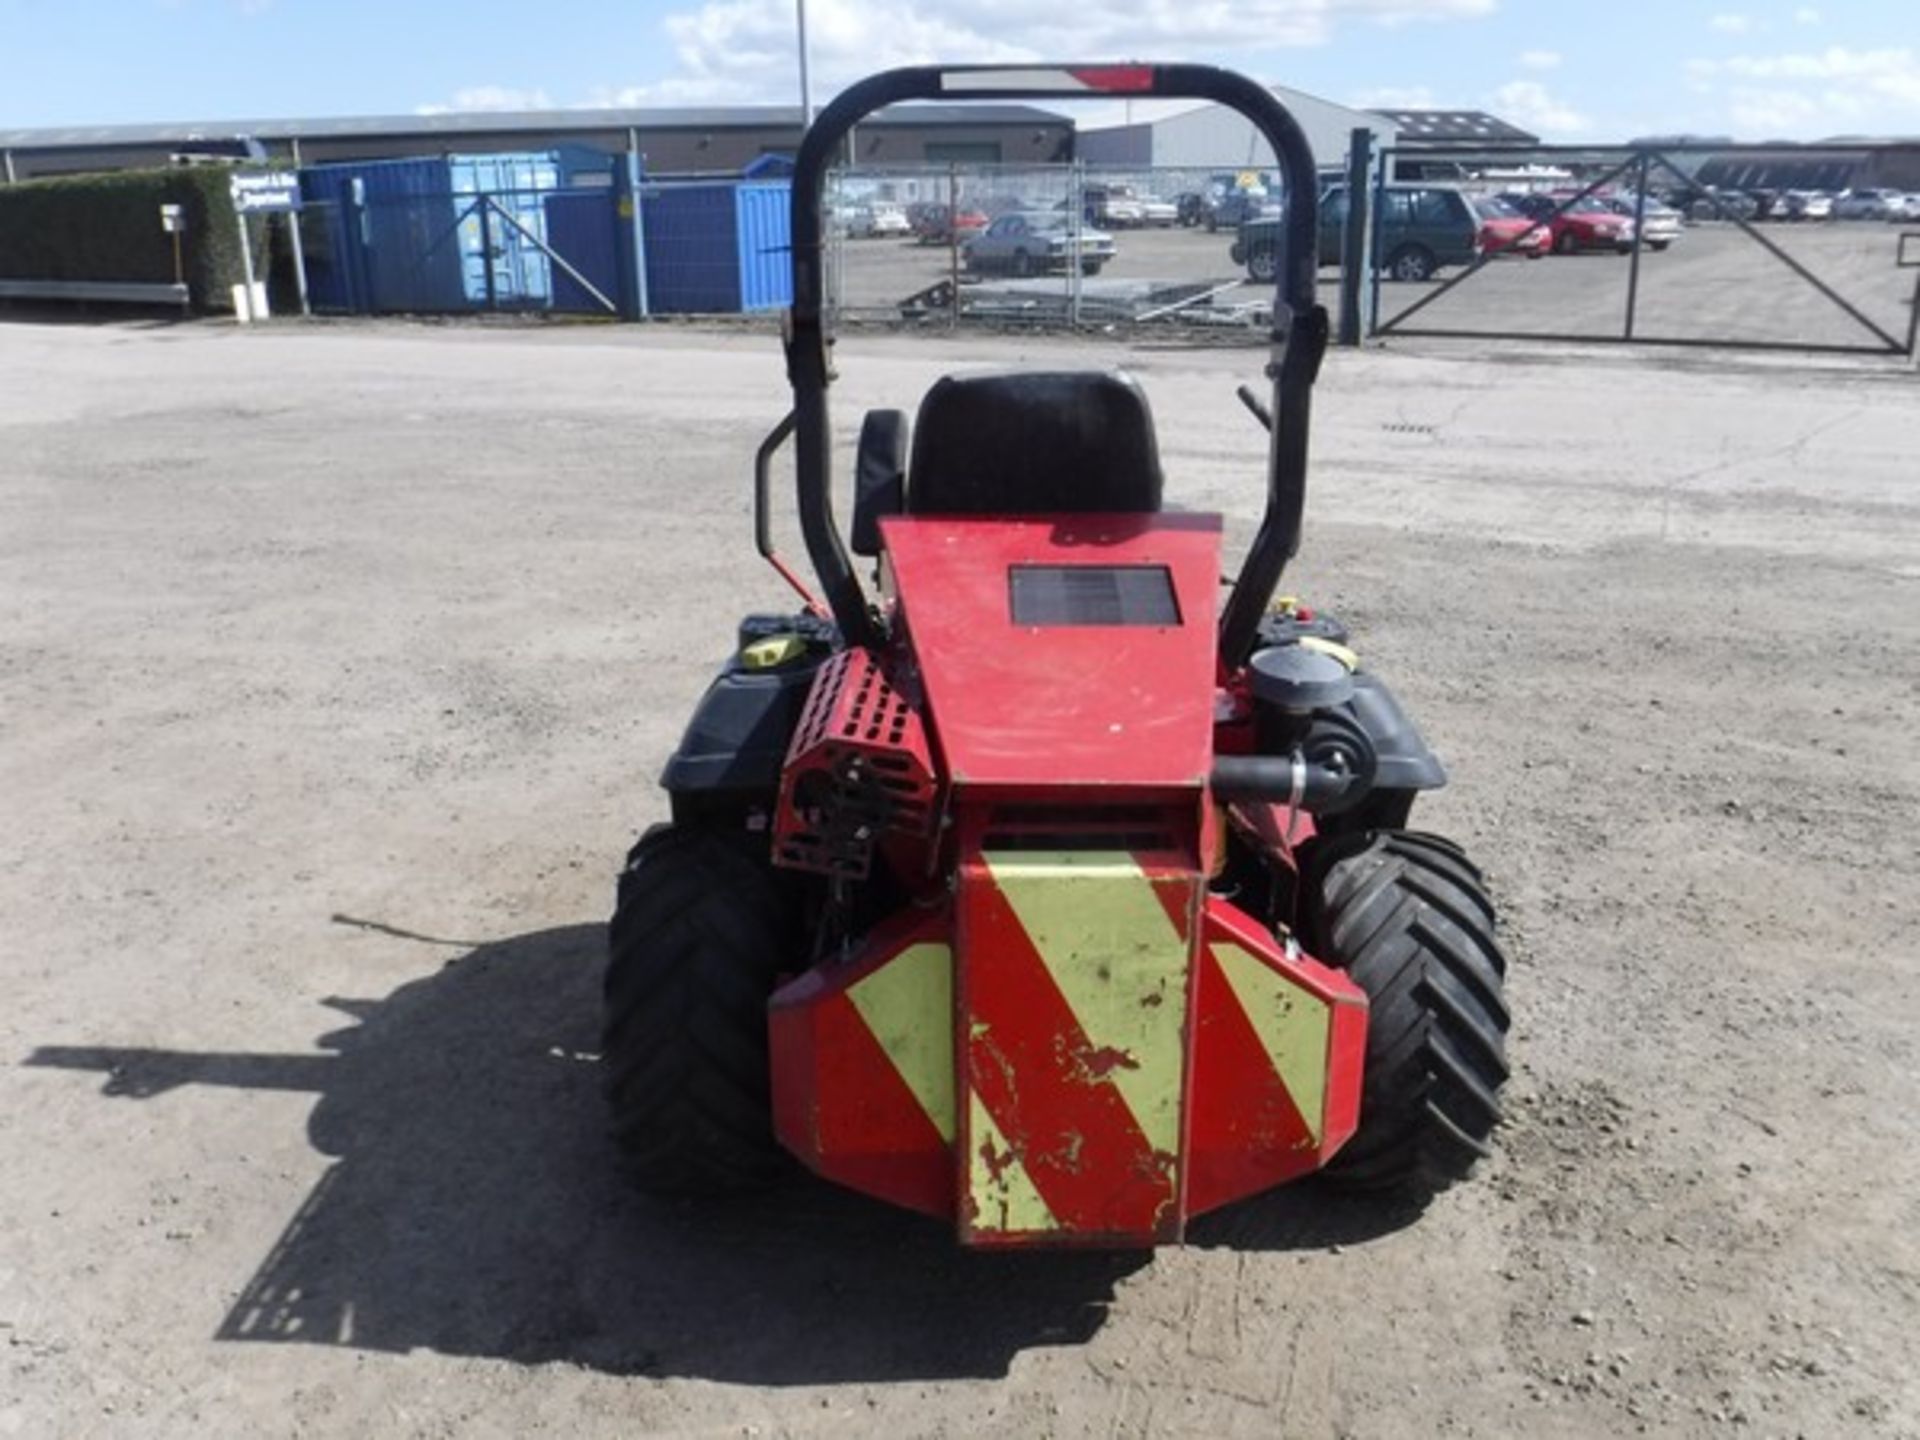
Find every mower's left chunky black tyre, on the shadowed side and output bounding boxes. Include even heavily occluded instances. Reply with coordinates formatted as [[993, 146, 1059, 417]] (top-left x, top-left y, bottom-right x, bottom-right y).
[[601, 826, 797, 1196]]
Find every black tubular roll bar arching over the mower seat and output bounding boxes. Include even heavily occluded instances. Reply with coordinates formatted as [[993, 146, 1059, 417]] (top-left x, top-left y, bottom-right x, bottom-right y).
[[785, 65, 1327, 666]]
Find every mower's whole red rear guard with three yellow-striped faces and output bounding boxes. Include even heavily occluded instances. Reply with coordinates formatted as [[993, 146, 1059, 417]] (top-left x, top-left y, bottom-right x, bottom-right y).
[[770, 851, 1367, 1246]]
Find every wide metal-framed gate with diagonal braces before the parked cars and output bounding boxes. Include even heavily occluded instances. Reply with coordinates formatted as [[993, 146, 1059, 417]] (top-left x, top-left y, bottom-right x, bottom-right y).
[[1367, 146, 1920, 359]]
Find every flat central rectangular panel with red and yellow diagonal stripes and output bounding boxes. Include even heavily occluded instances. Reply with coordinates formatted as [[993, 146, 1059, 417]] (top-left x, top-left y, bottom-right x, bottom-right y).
[[958, 851, 1200, 1244]]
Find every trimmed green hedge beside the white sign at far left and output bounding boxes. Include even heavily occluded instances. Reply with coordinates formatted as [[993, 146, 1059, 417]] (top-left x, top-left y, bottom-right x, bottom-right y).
[[0, 165, 267, 313]]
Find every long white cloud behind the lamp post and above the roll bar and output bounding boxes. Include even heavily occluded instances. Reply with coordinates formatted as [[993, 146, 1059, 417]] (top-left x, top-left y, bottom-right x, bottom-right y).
[[618, 0, 1498, 104]]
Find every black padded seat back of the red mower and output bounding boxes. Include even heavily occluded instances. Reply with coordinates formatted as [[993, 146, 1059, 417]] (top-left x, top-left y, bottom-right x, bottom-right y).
[[906, 371, 1162, 515]]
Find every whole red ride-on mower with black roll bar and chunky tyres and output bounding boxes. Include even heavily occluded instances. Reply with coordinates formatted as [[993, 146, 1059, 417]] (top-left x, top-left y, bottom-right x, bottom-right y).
[[605, 65, 1507, 1246]]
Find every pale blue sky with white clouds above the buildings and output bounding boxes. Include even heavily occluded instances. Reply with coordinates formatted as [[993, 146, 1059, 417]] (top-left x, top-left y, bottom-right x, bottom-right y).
[[0, 0, 1920, 140]]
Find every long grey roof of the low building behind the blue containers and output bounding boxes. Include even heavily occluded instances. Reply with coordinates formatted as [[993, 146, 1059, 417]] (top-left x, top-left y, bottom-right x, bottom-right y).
[[0, 106, 1071, 150]]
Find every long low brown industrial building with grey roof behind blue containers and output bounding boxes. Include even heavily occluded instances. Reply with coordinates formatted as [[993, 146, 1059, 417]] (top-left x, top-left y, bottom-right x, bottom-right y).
[[0, 106, 1073, 180]]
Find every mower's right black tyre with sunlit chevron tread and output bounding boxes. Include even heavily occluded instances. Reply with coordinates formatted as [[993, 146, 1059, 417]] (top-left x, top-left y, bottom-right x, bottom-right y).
[[1302, 829, 1509, 1192]]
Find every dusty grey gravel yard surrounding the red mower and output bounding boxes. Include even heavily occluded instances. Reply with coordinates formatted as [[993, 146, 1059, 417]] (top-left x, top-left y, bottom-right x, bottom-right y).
[[0, 318, 1920, 1440]]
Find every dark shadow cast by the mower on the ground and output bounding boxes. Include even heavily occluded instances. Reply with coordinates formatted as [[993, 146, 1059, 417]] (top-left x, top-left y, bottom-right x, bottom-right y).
[[27, 925, 1148, 1384]]
